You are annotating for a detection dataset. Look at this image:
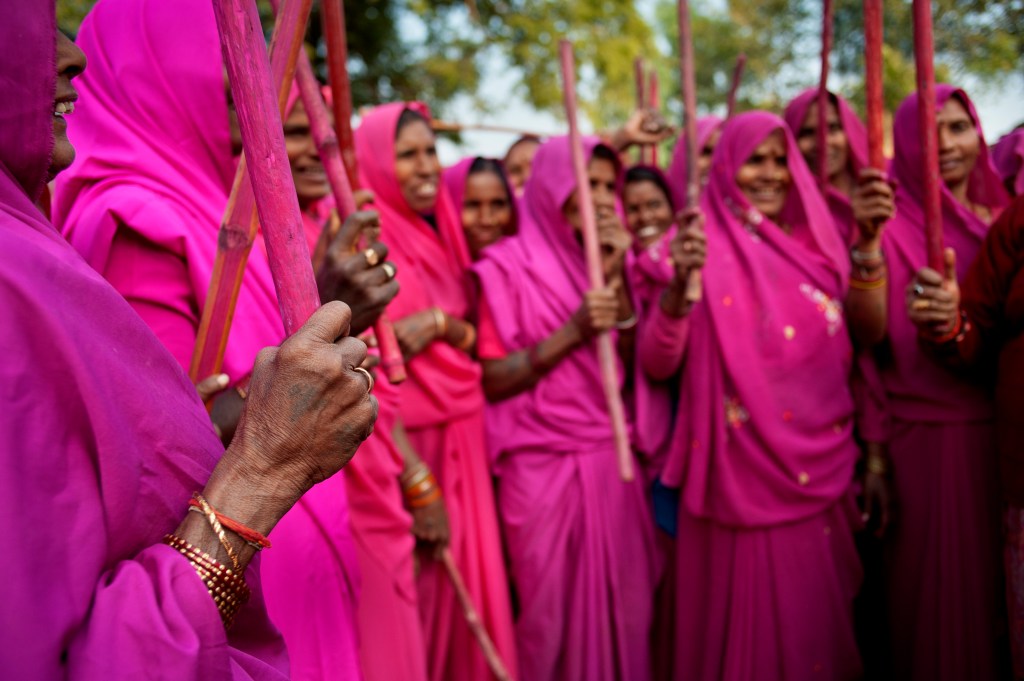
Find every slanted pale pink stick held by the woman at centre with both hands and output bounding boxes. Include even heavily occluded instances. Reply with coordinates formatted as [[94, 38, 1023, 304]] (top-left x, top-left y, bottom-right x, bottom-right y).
[[559, 39, 633, 481]]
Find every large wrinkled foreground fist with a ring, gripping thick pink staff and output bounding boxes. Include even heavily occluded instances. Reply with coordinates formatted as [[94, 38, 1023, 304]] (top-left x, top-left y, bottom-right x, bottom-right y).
[[222, 302, 377, 503]]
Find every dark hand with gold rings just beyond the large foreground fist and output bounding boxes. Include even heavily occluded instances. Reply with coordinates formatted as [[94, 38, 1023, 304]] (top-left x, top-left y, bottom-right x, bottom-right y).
[[316, 211, 398, 334]]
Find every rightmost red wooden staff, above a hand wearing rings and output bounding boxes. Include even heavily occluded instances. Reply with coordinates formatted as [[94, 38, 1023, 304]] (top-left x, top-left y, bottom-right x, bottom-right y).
[[913, 0, 944, 272]]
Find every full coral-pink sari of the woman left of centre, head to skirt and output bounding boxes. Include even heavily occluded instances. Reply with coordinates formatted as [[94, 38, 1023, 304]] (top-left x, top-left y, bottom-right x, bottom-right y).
[[355, 102, 515, 681]]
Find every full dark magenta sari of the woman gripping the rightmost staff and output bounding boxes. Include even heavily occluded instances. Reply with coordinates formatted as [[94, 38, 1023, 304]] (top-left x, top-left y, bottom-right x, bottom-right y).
[[881, 85, 1008, 680]]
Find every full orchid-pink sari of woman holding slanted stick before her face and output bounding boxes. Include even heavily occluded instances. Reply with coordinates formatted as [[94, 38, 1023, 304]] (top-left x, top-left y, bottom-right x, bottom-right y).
[[474, 137, 657, 681]]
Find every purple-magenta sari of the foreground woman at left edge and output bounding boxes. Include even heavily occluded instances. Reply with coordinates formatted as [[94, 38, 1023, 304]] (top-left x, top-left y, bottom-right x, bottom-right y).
[[0, 0, 287, 680]]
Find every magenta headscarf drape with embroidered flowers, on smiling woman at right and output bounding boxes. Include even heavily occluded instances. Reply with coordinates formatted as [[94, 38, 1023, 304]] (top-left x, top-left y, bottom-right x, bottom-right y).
[[663, 112, 857, 527]]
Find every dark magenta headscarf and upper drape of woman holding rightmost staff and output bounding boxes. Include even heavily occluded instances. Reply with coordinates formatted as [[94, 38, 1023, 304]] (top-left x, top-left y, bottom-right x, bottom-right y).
[[883, 85, 1010, 422]]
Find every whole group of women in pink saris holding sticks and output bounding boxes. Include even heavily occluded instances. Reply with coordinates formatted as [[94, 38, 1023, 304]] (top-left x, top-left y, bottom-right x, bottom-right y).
[[6, 0, 1024, 681]]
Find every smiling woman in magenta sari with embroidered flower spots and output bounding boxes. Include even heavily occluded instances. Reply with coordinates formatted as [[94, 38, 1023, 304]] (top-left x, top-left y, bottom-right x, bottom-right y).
[[640, 112, 861, 681]]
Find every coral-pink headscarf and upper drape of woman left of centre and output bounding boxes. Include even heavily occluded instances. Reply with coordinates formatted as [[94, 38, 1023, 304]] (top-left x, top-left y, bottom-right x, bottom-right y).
[[355, 102, 483, 428]]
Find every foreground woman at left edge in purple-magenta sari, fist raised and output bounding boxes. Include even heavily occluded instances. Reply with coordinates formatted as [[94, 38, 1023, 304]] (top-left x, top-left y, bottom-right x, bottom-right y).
[[0, 0, 376, 680]]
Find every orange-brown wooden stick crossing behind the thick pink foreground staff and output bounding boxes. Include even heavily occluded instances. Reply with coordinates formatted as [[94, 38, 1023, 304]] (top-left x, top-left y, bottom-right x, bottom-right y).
[[188, 0, 312, 382]]
